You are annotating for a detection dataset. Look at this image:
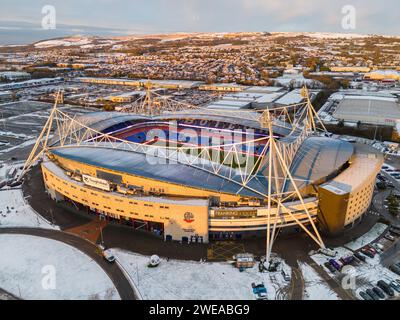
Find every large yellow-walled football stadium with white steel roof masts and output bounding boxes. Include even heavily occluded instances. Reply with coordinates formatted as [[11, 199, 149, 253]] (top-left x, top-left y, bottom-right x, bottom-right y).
[[24, 89, 383, 258]]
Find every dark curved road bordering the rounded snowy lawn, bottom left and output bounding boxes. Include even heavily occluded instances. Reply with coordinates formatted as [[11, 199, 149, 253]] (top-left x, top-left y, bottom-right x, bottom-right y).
[[0, 227, 137, 300]]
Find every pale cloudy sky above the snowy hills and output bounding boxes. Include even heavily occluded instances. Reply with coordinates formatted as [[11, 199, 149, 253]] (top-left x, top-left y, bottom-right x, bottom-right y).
[[0, 0, 400, 44]]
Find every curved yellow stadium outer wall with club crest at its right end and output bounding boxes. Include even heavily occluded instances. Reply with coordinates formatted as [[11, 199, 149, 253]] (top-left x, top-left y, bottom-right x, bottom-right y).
[[42, 164, 208, 242]]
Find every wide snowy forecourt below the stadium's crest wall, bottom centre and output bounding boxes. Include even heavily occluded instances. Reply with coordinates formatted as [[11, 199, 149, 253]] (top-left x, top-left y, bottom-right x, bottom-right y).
[[109, 249, 290, 300]]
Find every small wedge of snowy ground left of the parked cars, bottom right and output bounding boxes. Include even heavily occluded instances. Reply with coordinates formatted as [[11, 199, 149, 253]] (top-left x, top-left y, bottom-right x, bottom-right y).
[[298, 261, 340, 300]]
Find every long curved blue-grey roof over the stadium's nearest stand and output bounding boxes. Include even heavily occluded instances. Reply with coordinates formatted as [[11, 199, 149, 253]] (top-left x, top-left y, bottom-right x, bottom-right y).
[[51, 147, 268, 197]]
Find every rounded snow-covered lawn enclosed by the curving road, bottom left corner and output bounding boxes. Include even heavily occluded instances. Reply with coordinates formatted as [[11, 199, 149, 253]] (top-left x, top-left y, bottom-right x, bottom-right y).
[[0, 234, 120, 300]]
